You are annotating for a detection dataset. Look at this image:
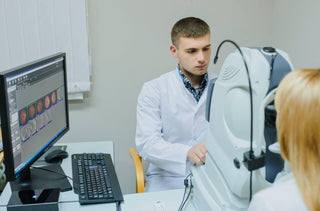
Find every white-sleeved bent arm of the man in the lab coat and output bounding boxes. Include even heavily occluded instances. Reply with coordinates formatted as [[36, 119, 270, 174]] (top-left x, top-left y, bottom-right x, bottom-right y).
[[136, 83, 191, 175]]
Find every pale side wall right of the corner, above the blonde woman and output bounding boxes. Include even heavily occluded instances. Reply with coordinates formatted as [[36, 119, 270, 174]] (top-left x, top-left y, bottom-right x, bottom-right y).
[[272, 0, 320, 69]]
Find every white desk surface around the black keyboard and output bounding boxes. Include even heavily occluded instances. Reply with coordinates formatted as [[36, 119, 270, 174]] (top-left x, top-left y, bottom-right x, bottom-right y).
[[0, 141, 184, 211]]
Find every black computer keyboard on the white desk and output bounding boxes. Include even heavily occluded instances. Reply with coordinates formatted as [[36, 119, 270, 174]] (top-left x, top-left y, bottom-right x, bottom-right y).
[[71, 153, 123, 205]]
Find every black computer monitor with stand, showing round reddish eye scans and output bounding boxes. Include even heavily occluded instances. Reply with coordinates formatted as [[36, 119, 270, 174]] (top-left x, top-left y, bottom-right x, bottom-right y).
[[0, 53, 72, 191]]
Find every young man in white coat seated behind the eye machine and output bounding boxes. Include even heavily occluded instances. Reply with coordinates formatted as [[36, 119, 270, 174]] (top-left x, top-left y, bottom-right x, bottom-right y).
[[135, 17, 216, 191]]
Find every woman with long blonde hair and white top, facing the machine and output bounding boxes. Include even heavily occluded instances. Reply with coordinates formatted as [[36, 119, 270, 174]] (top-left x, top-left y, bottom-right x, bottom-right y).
[[248, 69, 320, 211]]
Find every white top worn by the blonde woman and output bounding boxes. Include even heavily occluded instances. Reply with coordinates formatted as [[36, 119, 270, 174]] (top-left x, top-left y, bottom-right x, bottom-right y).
[[248, 173, 308, 211]]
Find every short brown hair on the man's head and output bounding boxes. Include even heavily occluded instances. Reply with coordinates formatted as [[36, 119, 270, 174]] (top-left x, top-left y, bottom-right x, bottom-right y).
[[171, 17, 210, 46]]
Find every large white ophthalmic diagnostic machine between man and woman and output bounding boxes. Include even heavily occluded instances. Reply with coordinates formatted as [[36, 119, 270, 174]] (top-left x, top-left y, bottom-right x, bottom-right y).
[[185, 40, 293, 211]]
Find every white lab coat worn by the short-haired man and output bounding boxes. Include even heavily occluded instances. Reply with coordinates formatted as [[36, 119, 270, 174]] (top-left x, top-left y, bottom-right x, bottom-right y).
[[136, 69, 216, 191]]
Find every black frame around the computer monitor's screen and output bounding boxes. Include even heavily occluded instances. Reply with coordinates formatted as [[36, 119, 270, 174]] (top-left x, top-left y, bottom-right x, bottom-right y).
[[0, 52, 70, 181]]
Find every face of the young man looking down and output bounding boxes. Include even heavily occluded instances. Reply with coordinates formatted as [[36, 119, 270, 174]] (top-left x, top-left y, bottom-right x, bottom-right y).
[[170, 33, 211, 76]]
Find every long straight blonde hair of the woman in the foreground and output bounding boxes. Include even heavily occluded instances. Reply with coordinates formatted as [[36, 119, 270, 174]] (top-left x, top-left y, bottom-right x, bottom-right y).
[[275, 69, 320, 211]]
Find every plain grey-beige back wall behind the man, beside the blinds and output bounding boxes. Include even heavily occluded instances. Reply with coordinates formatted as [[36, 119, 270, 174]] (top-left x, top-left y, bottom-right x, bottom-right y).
[[63, 0, 273, 193]]
